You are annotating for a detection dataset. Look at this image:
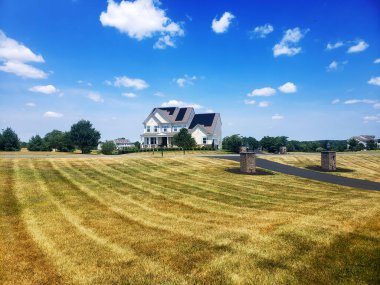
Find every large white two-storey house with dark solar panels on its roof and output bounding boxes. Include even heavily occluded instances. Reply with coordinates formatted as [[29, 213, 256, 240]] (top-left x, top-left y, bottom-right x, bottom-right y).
[[141, 107, 222, 148]]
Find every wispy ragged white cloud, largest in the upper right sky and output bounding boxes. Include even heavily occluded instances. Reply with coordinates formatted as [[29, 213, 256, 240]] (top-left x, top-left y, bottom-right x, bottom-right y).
[[273, 27, 308, 57]]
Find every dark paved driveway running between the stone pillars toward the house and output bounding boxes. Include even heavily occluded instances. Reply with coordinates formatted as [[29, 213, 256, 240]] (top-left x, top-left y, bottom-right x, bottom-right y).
[[209, 155, 380, 191]]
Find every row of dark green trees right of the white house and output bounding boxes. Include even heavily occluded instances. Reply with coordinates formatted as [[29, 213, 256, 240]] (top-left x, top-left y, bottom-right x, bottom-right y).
[[222, 134, 377, 153]]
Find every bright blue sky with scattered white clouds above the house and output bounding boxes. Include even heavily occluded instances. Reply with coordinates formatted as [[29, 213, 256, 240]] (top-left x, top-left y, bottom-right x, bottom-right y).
[[0, 0, 380, 140]]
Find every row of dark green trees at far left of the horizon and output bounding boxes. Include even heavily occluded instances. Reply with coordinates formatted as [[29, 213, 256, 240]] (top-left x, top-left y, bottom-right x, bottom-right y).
[[0, 120, 100, 153]]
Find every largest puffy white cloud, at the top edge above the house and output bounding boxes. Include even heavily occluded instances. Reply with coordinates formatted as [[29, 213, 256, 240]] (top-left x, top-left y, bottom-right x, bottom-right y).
[[100, 0, 184, 49]]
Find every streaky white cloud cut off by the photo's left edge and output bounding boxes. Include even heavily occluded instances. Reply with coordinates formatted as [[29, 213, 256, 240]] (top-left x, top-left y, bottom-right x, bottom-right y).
[[0, 30, 47, 79]]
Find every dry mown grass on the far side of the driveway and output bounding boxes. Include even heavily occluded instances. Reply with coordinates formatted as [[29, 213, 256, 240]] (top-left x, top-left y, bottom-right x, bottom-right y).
[[261, 151, 380, 182]]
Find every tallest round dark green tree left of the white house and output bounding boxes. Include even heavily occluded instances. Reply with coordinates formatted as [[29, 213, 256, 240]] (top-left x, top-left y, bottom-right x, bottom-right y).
[[70, 120, 100, 153]]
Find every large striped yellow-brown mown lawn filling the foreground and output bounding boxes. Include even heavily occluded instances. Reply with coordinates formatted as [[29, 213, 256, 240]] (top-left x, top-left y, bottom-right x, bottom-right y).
[[0, 157, 380, 284]]
